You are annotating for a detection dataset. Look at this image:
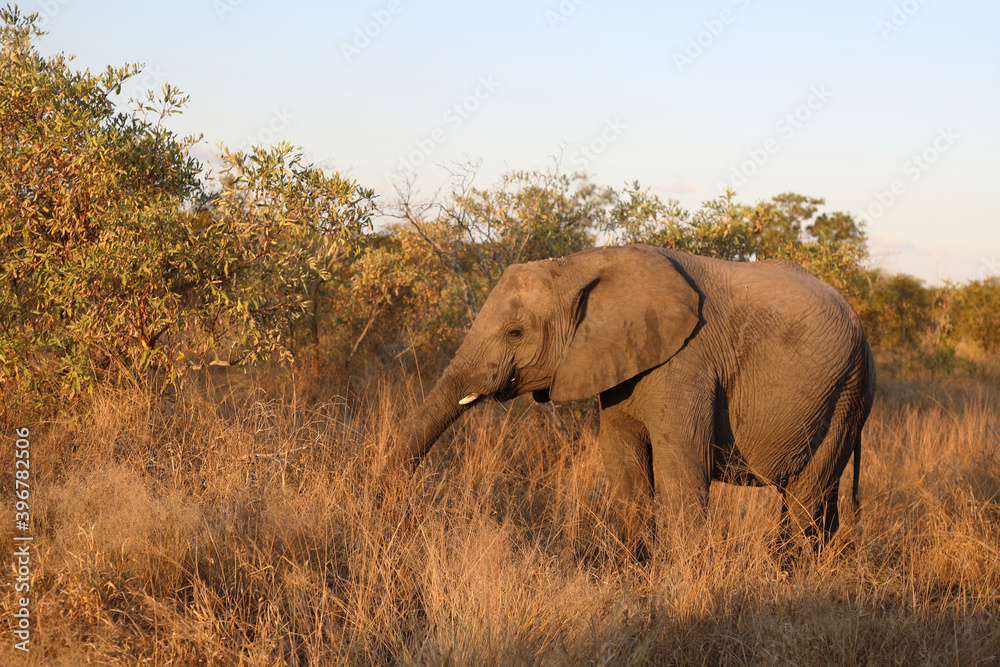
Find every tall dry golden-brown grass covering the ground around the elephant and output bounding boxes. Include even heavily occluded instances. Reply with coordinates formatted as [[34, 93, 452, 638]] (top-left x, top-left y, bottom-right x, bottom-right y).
[[0, 368, 1000, 665]]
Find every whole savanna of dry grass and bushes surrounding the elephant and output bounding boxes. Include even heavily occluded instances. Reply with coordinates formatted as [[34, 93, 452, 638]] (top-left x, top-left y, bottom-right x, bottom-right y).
[[0, 6, 1000, 666]]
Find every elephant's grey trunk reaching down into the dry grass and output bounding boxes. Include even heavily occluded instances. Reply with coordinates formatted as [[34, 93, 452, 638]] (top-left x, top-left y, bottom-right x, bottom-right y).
[[390, 363, 474, 470]]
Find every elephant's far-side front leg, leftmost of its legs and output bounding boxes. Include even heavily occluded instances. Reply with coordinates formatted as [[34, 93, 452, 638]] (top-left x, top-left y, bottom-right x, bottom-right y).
[[600, 410, 653, 560]]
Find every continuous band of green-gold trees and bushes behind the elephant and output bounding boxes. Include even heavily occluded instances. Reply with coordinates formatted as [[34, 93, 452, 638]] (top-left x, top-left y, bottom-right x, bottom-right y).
[[0, 2, 1000, 410]]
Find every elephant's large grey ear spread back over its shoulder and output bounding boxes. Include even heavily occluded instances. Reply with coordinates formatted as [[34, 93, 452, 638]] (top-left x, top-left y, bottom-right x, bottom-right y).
[[549, 246, 699, 401]]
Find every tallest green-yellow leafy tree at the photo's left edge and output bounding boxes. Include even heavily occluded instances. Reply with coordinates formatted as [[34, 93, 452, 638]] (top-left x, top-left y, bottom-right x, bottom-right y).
[[0, 7, 198, 391]]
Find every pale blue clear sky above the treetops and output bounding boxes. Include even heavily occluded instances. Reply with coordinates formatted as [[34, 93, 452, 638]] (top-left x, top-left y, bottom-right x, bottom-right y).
[[27, 0, 1000, 283]]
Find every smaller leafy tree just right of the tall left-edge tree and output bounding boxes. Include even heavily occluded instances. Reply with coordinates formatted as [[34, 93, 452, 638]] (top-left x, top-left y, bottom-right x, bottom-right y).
[[193, 143, 375, 365]]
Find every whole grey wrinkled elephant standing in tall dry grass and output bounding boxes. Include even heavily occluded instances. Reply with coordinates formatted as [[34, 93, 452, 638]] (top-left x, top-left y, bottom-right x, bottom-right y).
[[393, 245, 875, 548]]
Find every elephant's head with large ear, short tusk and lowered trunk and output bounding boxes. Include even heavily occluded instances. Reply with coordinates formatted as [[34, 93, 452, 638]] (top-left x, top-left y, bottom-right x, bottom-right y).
[[395, 245, 699, 465]]
